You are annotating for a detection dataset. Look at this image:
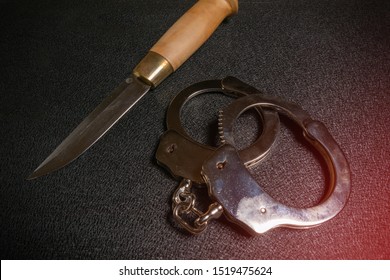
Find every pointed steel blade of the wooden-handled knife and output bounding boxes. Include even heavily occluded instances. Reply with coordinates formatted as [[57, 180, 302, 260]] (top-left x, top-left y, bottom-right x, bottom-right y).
[[27, 78, 150, 180]]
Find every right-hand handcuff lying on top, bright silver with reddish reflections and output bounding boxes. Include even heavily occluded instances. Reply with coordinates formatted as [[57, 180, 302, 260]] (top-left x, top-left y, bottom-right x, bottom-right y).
[[202, 95, 351, 234]]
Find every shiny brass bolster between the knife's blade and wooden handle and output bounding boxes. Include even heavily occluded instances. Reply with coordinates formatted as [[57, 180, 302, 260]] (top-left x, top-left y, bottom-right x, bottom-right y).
[[133, 51, 174, 88]]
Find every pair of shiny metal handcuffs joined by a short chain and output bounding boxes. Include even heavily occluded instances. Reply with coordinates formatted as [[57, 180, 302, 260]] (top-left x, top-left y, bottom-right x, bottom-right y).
[[156, 77, 351, 234]]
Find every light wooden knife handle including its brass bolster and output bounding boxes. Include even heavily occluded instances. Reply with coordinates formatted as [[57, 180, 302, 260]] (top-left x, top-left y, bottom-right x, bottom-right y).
[[133, 0, 238, 87]]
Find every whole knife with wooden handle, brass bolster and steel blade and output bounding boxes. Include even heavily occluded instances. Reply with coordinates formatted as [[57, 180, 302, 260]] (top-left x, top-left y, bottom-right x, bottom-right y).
[[27, 0, 238, 180]]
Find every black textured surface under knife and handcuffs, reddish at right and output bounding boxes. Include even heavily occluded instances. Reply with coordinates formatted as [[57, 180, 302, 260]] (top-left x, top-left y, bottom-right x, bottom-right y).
[[0, 0, 390, 259]]
